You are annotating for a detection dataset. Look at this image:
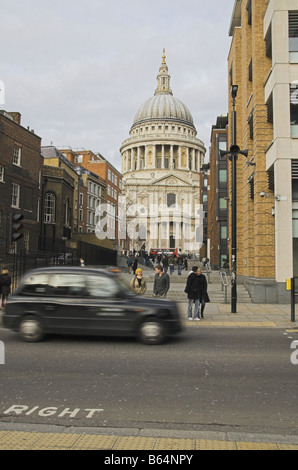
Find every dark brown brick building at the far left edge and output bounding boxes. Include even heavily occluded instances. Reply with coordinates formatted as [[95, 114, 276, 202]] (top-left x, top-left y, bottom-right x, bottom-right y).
[[0, 111, 43, 258]]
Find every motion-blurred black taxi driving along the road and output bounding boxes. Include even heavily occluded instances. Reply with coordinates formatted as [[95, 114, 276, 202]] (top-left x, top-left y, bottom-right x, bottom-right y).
[[2, 267, 182, 344]]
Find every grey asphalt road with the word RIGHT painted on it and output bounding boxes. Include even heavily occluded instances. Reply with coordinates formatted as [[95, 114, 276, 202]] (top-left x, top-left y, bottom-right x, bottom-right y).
[[0, 325, 298, 435]]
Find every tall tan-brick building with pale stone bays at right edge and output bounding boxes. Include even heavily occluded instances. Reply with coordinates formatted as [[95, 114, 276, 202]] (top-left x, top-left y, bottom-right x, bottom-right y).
[[228, 0, 298, 303]]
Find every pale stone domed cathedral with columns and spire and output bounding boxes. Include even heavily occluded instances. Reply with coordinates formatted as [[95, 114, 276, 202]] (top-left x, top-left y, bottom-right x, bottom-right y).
[[120, 51, 206, 252]]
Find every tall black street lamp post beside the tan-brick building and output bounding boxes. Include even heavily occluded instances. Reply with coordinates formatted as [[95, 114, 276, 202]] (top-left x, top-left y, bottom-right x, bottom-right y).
[[220, 85, 248, 313]]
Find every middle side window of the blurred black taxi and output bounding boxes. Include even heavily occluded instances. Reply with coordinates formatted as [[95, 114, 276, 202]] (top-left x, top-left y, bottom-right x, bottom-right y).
[[48, 273, 86, 297]]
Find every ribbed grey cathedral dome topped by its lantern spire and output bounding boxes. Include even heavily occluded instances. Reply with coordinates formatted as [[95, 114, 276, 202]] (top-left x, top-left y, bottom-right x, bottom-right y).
[[132, 51, 195, 129]]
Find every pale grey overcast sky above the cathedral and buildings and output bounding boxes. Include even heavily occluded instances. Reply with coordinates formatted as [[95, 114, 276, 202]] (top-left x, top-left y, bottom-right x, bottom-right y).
[[0, 0, 234, 169]]
